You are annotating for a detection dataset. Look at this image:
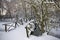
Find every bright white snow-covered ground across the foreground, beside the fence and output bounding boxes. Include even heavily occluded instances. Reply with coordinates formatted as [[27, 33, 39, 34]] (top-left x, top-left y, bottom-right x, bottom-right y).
[[0, 22, 60, 40]]
